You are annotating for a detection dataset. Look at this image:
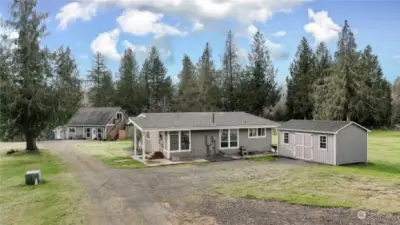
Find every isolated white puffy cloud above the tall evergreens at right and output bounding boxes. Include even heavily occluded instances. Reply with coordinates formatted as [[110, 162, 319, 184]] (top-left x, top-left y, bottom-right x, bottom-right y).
[[304, 9, 341, 43]]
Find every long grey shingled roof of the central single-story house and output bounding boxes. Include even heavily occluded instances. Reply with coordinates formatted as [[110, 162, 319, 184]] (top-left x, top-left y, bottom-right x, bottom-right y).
[[130, 112, 279, 130]]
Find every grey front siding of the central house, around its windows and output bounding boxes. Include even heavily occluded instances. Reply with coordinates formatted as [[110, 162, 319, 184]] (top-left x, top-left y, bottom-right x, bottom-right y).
[[167, 128, 272, 158]]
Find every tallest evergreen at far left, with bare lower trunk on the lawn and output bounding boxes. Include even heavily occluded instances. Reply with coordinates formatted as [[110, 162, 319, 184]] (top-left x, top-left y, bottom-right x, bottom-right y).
[[0, 0, 80, 151]]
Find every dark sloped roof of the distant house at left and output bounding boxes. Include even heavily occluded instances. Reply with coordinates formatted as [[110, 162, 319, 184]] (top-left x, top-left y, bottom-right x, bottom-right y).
[[67, 107, 121, 126]]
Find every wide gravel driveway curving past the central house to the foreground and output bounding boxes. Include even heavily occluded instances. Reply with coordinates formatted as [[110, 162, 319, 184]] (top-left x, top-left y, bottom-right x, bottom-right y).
[[41, 141, 400, 225]]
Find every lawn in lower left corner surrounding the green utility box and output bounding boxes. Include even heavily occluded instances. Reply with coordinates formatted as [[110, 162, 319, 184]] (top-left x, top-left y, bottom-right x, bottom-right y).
[[0, 149, 86, 225]]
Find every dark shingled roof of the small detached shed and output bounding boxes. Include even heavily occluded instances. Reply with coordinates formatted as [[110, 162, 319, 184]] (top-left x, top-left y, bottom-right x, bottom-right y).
[[278, 120, 370, 133]]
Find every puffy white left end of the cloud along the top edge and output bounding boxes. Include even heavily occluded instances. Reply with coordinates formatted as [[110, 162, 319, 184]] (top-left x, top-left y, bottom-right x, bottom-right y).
[[56, 1, 98, 30]]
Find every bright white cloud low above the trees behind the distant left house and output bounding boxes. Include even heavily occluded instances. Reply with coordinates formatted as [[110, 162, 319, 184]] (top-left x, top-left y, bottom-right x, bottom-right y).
[[90, 29, 121, 60]]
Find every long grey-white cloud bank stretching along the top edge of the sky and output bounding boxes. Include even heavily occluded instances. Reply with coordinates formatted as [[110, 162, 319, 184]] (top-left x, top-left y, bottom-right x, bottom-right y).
[[57, 0, 311, 28]]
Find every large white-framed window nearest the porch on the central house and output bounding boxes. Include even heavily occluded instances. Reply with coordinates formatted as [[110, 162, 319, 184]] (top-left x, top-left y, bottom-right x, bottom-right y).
[[168, 131, 191, 152]]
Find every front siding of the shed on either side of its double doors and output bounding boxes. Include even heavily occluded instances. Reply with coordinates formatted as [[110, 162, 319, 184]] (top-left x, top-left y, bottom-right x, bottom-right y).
[[278, 131, 335, 165]]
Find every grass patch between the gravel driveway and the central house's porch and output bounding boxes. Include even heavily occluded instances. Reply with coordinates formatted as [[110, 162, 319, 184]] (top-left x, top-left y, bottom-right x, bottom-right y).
[[76, 140, 146, 168]]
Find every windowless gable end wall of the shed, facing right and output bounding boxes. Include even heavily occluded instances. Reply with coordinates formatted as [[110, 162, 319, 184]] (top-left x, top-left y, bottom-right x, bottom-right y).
[[336, 124, 368, 165]]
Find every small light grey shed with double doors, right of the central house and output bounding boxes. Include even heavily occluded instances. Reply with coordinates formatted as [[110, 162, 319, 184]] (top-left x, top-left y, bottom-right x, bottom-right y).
[[277, 120, 370, 165]]
